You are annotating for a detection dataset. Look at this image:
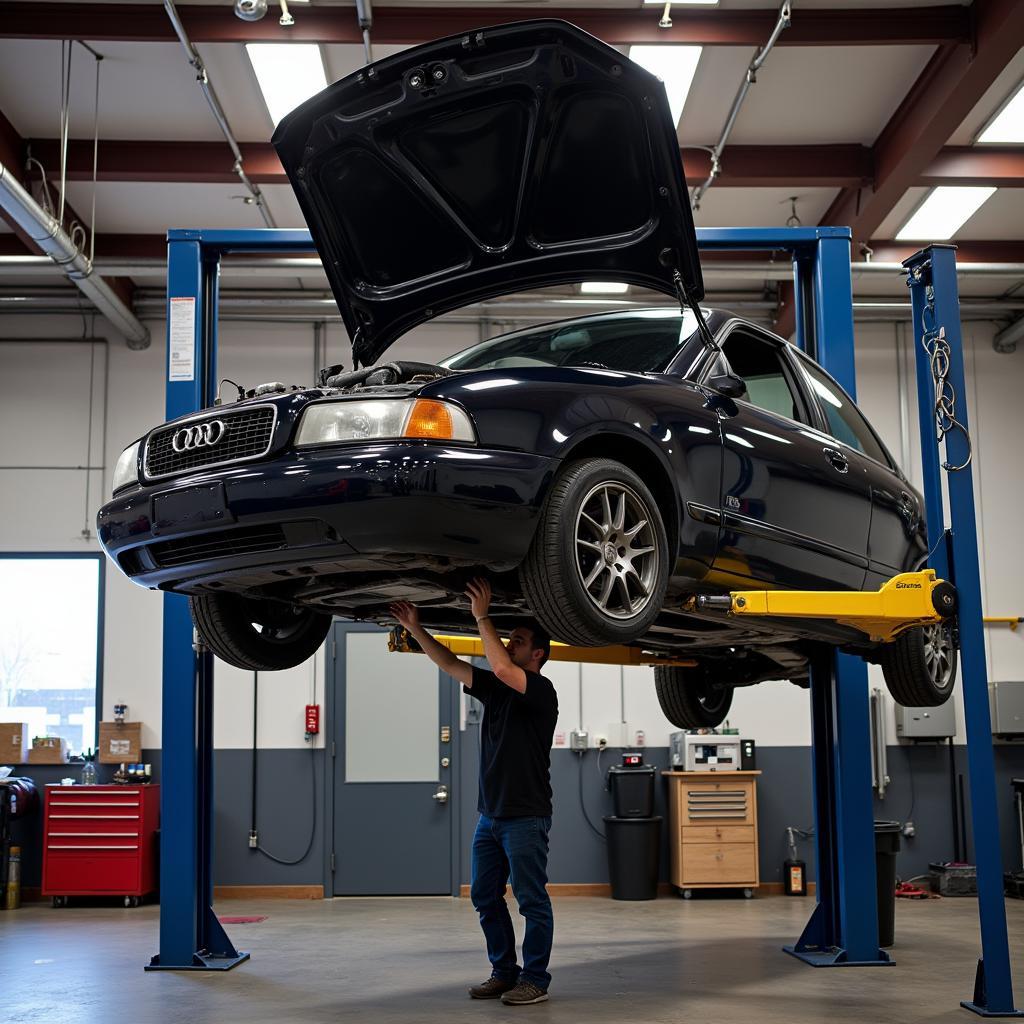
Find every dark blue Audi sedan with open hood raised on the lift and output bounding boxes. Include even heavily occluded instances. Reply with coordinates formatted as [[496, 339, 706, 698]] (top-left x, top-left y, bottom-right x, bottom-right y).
[[98, 20, 955, 727]]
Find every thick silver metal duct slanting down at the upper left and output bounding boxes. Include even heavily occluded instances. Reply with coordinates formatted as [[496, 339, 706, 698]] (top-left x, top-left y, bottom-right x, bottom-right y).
[[0, 164, 150, 348]]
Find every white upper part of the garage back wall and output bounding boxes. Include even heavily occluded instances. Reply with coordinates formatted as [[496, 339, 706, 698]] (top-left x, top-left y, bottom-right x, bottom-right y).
[[0, 316, 1024, 748]]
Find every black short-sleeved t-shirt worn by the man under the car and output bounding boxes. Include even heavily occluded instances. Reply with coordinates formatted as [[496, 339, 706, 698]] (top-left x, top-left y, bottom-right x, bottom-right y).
[[464, 666, 558, 818]]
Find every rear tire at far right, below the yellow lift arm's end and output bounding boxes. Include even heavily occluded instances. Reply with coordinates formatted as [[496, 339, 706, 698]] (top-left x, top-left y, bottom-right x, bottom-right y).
[[880, 620, 956, 708]]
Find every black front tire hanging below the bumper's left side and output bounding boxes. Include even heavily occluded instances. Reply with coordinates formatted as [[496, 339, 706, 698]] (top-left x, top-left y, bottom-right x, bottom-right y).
[[188, 594, 331, 672]]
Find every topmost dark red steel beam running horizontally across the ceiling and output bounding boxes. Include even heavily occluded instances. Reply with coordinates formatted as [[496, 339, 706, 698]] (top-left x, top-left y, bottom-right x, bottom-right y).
[[0, 0, 971, 46]]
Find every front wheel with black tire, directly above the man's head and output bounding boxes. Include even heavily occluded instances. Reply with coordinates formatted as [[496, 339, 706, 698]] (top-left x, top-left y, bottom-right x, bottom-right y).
[[519, 459, 669, 647]]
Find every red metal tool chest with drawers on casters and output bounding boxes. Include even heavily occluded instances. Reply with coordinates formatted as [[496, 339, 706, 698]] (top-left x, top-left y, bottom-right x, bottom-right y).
[[42, 785, 160, 906]]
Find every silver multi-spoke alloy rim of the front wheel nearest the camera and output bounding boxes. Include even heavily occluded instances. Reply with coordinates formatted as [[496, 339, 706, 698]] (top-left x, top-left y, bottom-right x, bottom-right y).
[[574, 480, 660, 620]]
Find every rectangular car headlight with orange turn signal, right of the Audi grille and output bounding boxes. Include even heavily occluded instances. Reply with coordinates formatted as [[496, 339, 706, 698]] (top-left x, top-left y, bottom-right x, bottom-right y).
[[295, 398, 476, 445]]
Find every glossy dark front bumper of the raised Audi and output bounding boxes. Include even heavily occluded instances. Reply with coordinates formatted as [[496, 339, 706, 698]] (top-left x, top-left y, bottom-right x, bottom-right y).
[[97, 442, 556, 590]]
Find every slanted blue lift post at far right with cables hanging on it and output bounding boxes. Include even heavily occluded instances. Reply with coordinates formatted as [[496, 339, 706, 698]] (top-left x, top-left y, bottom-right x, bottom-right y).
[[903, 246, 1024, 1017]]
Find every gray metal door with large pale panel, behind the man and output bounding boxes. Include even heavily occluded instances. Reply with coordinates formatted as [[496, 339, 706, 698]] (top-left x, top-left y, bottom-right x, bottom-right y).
[[329, 624, 459, 896]]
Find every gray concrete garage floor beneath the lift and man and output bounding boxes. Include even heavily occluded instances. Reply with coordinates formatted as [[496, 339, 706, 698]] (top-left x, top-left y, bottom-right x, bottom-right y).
[[0, 897, 1024, 1024]]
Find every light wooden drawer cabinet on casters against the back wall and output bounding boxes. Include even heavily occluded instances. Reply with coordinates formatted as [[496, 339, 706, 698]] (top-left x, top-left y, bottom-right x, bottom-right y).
[[662, 771, 761, 899]]
